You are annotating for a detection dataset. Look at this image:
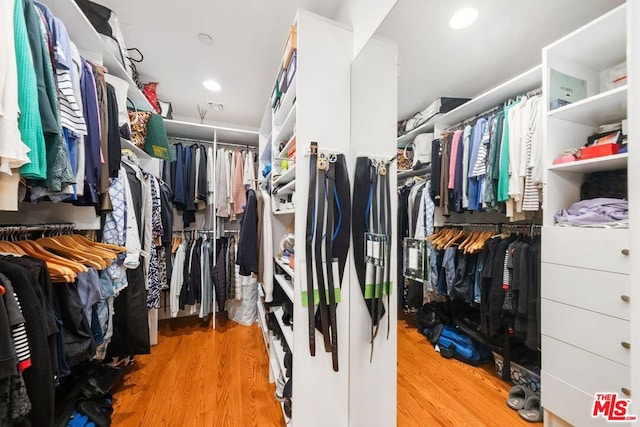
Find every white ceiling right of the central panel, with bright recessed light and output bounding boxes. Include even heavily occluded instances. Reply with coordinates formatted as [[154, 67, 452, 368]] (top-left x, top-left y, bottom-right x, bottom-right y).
[[376, 0, 624, 119]]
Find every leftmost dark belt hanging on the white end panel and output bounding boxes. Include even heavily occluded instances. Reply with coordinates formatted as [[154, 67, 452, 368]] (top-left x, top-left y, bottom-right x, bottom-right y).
[[305, 142, 318, 356]]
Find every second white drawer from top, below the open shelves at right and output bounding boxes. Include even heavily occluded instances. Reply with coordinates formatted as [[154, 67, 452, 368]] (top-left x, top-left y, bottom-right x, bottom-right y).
[[541, 263, 631, 320]]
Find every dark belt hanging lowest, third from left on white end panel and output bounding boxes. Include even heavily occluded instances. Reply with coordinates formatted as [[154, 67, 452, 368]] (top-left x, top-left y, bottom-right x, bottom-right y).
[[320, 156, 338, 372]]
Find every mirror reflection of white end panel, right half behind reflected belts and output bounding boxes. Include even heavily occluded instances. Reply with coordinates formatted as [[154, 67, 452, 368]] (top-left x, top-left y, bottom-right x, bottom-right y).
[[349, 38, 399, 427]]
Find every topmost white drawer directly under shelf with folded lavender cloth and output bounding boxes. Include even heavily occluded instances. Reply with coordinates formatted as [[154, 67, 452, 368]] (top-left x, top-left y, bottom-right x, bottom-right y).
[[542, 227, 630, 274]]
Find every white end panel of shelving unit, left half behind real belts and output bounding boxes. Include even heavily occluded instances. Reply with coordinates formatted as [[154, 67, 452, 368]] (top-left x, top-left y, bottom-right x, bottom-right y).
[[292, 10, 353, 427]]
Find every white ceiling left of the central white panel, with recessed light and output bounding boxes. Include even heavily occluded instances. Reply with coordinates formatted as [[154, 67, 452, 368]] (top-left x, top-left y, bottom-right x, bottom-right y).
[[94, 0, 341, 129]]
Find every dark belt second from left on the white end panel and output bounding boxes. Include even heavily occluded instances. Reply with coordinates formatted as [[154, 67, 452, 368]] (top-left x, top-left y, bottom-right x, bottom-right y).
[[314, 154, 331, 352]]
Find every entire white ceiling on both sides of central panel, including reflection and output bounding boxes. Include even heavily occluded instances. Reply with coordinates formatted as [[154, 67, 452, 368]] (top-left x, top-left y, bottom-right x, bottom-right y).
[[92, 0, 623, 129]]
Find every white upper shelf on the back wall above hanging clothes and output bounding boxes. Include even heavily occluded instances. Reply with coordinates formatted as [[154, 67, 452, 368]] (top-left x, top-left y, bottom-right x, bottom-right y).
[[164, 119, 258, 147]]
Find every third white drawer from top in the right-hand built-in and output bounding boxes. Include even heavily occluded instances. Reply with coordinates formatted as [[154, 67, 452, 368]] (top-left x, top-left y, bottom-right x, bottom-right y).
[[541, 298, 631, 366]]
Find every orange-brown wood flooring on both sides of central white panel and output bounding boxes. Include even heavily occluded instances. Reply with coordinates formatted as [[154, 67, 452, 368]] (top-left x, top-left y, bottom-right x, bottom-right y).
[[112, 318, 529, 427]]
